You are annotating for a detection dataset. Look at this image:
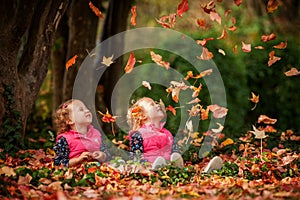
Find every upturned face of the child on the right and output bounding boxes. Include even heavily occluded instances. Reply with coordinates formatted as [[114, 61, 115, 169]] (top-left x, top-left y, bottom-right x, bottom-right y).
[[141, 98, 166, 122]]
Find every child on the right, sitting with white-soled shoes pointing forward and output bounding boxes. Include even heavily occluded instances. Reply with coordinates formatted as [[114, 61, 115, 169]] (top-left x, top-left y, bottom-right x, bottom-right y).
[[127, 97, 223, 173]]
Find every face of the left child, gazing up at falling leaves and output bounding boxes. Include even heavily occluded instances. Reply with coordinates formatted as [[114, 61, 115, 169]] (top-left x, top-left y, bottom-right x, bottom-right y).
[[70, 100, 93, 126]]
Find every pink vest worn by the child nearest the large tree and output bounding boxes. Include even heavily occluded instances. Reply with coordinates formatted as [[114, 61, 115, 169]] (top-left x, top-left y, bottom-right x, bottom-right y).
[[56, 125, 102, 159]]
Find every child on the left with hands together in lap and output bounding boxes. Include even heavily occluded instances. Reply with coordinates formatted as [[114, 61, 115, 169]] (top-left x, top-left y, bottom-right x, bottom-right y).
[[53, 99, 111, 167]]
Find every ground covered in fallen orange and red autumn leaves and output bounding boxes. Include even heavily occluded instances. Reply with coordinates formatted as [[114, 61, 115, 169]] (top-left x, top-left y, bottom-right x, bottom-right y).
[[0, 131, 300, 199]]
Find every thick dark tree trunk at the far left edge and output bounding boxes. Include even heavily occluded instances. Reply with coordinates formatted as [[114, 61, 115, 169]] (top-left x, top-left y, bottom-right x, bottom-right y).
[[0, 0, 68, 143]]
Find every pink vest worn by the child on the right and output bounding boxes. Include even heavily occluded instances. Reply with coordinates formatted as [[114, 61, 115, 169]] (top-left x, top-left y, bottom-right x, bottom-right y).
[[132, 123, 173, 163]]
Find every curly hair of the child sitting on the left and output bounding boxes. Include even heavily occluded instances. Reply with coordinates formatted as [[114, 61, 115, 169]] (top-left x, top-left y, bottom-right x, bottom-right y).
[[53, 99, 74, 135]]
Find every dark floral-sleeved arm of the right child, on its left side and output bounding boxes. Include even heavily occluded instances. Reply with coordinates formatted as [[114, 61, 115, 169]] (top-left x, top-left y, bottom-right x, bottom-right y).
[[129, 132, 144, 160]]
